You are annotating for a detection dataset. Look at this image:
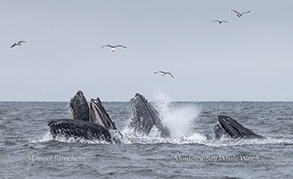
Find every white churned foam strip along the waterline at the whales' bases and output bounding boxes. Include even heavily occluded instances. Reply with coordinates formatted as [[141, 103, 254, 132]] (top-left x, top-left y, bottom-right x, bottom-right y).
[[34, 127, 293, 147]]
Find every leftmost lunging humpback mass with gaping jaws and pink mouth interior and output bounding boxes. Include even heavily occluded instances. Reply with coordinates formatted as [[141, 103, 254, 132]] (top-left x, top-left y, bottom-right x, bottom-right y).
[[48, 91, 120, 142]]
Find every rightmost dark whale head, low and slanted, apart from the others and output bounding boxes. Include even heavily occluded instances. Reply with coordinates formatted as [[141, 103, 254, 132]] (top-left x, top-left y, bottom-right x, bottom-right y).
[[214, 115, 265, 139]]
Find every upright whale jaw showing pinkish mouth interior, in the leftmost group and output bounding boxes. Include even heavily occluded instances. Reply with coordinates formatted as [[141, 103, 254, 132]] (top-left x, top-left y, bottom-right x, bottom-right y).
[[89, 98, 116, 130]]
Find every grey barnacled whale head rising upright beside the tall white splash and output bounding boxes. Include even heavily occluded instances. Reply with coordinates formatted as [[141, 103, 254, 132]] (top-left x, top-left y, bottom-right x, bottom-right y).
[[127, 93, 170, 137]]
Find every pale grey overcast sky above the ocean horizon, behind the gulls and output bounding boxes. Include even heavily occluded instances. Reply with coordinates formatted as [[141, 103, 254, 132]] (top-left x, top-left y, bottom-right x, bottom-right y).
[[0, 0, 293, 101]]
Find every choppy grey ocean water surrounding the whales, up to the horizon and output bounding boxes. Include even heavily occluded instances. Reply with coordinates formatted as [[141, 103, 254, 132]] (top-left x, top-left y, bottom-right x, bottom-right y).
[[0, 100, 293, 179]]
